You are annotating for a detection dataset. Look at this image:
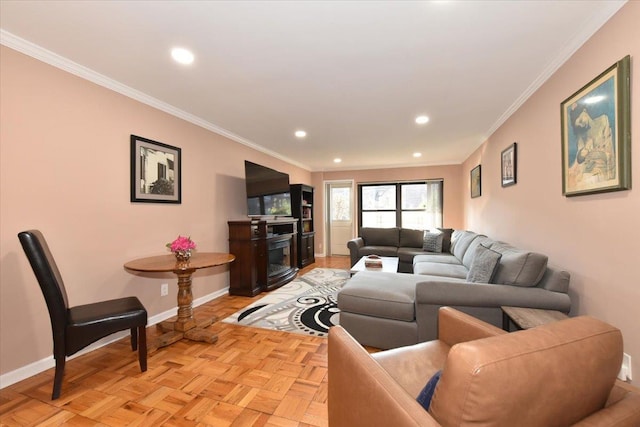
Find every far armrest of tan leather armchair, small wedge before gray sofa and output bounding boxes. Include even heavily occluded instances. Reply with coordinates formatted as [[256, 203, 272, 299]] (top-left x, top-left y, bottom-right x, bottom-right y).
[[438, 307, 506, 347]]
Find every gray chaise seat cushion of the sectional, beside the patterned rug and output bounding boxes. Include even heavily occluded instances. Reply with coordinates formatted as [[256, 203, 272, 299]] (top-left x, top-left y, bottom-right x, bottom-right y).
[[338, 271, 424, 322]]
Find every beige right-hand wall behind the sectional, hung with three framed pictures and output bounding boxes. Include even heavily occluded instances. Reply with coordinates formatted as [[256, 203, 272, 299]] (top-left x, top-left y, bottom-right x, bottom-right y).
[[462, 2, 640, 384]]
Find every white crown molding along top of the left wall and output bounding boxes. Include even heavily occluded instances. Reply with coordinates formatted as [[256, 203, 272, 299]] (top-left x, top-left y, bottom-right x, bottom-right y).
[[0, 30, 311, 170]]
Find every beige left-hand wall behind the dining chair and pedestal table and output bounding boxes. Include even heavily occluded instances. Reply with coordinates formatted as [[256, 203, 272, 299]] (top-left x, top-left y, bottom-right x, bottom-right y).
[[0, 47, 311, 374]]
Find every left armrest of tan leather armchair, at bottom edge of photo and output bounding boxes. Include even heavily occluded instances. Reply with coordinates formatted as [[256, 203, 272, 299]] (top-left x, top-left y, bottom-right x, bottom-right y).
[[328, 326, 439, 427]]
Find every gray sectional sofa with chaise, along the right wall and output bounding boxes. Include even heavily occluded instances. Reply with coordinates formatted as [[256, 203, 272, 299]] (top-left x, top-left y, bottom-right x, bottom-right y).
[[338, 230, 571, 349]]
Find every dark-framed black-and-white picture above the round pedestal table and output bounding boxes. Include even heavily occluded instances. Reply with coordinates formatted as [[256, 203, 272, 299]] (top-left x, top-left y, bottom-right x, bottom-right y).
[[131, 135, 182, 203]]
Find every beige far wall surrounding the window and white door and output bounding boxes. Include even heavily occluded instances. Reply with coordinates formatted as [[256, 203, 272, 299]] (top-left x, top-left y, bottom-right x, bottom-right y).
[[311, 165, 464, 254]]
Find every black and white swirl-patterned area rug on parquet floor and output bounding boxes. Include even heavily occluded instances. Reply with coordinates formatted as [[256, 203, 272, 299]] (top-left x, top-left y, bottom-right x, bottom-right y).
[[223, 268, 349, 337]]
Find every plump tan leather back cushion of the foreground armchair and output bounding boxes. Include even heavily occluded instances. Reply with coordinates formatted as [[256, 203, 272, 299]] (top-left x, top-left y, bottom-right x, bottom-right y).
[[429, 316, 622, 427]]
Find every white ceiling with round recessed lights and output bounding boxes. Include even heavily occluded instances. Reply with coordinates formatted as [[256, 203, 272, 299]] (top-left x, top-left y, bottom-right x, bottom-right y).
[[0, 0, 624, 171]]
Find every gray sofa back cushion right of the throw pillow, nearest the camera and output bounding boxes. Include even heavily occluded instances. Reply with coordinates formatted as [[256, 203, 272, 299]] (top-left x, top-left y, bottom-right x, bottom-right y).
[[491, 242, 548, 287]]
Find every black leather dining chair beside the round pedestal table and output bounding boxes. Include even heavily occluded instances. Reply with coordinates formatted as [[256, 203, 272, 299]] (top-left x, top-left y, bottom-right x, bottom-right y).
[[18, 230, 147, 400]]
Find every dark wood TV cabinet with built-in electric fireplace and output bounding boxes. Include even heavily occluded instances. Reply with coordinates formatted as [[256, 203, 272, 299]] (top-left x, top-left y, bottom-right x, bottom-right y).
[[228, 218, 298, 296]]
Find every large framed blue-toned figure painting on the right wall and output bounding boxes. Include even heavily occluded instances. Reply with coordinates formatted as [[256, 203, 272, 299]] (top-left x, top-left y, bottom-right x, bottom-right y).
[[561, 56, 631, 197]]
